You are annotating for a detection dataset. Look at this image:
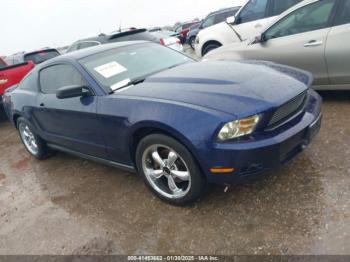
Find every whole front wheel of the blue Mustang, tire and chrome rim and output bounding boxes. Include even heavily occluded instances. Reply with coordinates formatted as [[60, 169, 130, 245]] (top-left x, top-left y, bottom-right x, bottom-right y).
[[136, 134, 207, 205]]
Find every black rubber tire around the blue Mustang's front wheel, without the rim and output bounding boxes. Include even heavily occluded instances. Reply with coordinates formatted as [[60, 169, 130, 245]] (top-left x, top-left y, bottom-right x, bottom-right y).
[[136, 134, 207, 206]]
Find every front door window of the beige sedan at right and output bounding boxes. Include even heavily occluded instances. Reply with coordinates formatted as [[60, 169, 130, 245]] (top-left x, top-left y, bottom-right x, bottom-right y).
[[265, 0, 335, 40]]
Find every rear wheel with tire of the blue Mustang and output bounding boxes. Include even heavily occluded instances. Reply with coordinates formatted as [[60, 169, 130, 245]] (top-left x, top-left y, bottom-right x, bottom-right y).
[[17, 117, 52, 160]]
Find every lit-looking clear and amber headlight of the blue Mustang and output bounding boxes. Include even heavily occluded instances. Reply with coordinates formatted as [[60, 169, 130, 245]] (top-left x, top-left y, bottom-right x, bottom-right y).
[[218, 115, 260, 141]]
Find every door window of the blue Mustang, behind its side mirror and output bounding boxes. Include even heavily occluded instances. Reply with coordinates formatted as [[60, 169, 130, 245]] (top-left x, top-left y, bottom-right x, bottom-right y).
[[39, 64, 86, 94]]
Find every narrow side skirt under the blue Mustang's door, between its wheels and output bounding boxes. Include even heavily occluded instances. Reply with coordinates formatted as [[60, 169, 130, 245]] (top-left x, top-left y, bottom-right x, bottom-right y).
[[47, 144, 136, 173]]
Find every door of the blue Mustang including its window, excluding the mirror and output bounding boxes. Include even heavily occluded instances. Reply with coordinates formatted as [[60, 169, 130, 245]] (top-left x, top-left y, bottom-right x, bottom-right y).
[[34, 64, 106, 157]]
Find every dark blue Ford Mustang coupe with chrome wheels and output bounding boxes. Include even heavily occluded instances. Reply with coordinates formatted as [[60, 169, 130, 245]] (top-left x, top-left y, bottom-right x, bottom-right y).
[[4, 42, 321, 204]]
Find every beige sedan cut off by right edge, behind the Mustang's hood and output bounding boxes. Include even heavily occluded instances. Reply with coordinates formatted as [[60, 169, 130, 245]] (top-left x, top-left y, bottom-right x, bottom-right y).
[[205, 0, 350, 89]]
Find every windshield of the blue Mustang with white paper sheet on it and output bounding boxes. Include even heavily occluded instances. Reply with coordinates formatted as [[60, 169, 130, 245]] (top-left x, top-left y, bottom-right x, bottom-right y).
[[79, 43, 194, 93]]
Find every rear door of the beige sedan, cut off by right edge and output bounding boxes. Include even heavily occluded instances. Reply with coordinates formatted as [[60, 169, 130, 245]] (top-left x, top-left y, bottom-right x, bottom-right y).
[[326, 0, 350, 85]]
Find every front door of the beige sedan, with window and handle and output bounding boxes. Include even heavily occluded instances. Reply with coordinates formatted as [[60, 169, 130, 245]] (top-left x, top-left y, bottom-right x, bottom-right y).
[[244, 0, 336, 85]]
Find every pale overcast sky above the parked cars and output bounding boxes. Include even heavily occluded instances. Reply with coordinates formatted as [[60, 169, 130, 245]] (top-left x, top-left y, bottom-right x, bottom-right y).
[[0, 0, 246, 55]]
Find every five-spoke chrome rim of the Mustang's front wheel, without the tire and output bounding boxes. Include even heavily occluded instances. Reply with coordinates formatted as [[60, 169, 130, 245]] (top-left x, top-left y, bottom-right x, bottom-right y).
[[142, 145, 191, 199]]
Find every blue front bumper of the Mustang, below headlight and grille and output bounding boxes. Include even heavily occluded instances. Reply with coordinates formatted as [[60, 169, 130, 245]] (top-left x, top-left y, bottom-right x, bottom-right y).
[[200, 90, 322, 184]]
